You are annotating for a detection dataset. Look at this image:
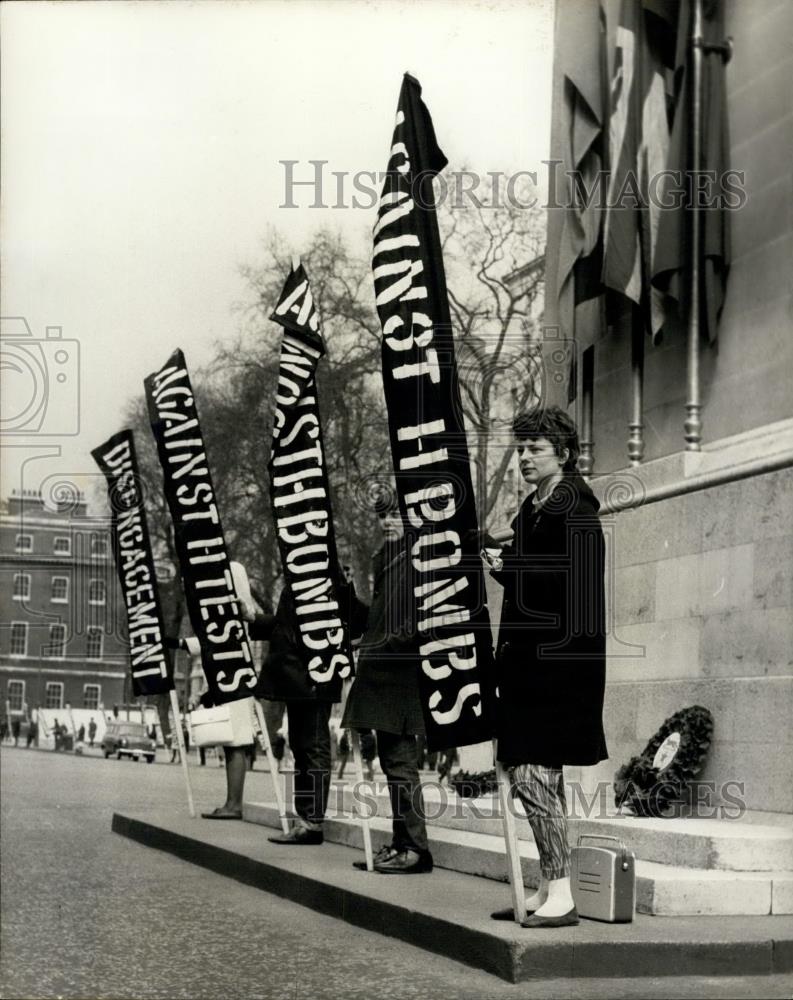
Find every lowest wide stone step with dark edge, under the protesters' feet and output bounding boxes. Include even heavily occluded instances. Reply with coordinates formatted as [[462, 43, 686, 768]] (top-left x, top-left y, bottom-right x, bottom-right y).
[[112, 809, 793, 980]]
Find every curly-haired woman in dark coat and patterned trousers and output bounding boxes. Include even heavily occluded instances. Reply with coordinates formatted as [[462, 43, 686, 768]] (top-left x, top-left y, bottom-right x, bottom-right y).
[[482, 407, 608, 927]]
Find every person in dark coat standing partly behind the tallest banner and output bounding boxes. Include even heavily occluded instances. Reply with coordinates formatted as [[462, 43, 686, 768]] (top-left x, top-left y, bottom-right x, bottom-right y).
[[342, 494, 432, 874]]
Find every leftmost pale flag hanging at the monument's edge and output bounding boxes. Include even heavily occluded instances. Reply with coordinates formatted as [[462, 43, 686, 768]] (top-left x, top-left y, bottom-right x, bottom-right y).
[[544, 0, 608, 402]]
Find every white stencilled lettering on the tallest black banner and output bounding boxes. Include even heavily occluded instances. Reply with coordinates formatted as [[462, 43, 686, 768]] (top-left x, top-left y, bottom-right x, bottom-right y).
[[372, 90, 482, 744]]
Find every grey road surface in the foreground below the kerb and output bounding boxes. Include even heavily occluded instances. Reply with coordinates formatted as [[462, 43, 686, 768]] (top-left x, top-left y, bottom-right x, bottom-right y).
[[0, 746, 793, 1000]]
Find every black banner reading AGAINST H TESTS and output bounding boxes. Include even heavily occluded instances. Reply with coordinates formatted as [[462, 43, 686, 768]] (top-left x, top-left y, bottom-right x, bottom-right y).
[[144, 349, 256, 704]]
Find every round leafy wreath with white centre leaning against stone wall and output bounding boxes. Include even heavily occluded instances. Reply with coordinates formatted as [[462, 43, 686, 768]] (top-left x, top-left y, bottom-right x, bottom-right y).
[[614, 705, 713, 816]]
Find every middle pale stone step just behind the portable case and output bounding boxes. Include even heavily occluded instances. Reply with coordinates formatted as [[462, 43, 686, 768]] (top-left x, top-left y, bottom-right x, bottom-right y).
[[243, 802, 793, 916]]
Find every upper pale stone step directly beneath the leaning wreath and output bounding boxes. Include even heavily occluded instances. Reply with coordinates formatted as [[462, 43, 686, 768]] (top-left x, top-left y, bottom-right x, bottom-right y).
[[320, 779, 793, 872]]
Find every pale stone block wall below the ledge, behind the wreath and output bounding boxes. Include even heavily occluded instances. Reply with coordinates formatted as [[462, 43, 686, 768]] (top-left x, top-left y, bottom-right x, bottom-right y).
[[583, 469, 793, 812]]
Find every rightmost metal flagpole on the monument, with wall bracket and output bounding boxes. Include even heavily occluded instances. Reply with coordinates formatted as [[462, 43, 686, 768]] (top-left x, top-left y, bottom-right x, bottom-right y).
[[684, 0, 703, 451]]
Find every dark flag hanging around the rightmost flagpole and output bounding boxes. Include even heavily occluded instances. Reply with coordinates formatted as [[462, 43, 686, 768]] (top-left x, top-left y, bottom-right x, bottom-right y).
[[653, 0, 730, 343]]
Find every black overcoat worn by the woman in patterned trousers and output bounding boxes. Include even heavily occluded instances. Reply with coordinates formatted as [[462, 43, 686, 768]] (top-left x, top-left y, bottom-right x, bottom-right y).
[[492, 474, 608, 766]]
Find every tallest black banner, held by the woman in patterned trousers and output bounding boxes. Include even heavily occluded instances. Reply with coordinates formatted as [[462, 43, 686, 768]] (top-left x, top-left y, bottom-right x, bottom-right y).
[[372, 74, 492, 748]]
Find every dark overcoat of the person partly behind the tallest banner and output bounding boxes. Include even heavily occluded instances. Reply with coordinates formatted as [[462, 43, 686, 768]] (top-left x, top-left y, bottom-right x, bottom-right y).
[[342, 539, 424, 735]]
